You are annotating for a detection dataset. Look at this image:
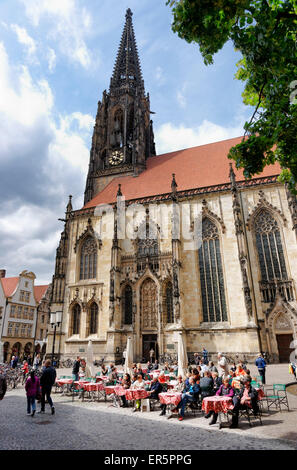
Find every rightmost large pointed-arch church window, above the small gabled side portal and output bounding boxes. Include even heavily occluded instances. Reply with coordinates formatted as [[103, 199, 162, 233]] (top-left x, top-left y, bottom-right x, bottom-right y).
[[254, 209, 288, 281]]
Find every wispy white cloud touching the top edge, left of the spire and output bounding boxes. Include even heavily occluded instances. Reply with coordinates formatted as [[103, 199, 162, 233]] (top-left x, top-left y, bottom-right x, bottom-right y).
[[20, 0, 92, 68]]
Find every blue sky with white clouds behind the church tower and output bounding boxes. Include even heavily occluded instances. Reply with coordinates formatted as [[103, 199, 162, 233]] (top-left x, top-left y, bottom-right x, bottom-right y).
[[0, 0, 250, 284]]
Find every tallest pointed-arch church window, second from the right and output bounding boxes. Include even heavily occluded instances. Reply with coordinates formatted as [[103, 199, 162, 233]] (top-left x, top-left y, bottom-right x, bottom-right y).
[[198, 217, 228, 322]]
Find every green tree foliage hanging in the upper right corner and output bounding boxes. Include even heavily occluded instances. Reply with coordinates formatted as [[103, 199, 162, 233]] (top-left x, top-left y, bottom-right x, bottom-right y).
[[167, 0, 297, 194]]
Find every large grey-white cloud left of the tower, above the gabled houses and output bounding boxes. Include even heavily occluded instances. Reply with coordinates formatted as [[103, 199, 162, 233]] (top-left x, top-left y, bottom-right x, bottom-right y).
[[0, 42, 94, 282]]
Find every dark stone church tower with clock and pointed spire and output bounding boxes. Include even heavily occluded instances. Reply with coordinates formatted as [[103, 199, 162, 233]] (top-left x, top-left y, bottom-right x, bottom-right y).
[[84, 9, 156, 204]]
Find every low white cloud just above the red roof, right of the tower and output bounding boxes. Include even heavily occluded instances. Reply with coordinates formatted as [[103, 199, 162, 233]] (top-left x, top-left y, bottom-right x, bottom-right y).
[[155, 120, 243, 154]]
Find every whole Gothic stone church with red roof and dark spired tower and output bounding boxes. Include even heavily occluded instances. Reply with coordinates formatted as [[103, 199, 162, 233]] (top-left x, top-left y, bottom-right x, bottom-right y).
[[48, 10, 297, 361]]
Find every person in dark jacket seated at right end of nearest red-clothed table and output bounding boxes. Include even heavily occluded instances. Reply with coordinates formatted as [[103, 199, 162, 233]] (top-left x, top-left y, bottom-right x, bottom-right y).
[[230, 376, 259, 428]]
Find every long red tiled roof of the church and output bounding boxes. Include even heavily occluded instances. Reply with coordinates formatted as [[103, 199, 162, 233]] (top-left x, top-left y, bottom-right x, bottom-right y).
[[84, 137, 281, 209]]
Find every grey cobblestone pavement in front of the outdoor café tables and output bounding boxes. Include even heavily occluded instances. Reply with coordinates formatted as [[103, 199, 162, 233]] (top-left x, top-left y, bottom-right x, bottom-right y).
[[0, 365, 297, 450]]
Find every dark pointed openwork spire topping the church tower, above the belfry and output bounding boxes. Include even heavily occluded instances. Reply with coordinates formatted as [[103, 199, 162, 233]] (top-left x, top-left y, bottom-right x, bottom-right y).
[[110, 8, 144, 93]]
